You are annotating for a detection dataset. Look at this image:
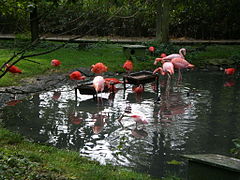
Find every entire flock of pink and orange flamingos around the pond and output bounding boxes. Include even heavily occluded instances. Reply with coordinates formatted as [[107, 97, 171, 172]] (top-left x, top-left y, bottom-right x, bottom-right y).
[[6, 46, 236, 124]]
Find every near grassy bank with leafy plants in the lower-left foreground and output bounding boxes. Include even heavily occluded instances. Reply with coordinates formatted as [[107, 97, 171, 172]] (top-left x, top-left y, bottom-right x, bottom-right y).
[[0, 127, 180, 180]]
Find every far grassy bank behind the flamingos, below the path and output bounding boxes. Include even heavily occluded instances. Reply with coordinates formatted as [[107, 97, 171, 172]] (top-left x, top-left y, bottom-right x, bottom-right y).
[[0, 40, 240, 86]]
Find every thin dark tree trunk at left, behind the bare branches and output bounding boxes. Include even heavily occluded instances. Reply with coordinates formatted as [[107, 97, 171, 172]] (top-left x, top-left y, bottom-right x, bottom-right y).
[[30, 5, 39, 41]]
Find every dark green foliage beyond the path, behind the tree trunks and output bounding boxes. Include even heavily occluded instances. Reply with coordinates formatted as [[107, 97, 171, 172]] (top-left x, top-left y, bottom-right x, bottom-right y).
[[0, 0, 240, 39]]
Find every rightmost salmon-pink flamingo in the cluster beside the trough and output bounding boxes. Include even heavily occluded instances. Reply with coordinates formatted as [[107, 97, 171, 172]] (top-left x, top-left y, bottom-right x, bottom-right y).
[[171, 58, 194, 81]]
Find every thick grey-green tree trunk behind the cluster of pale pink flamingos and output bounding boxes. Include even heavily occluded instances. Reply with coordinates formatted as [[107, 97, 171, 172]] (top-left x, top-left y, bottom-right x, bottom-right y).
[[156, 0, 170, 43]]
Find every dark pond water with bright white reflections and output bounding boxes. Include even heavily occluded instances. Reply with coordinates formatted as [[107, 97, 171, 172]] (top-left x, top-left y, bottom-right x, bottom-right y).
[[0, 71, 240, 178]]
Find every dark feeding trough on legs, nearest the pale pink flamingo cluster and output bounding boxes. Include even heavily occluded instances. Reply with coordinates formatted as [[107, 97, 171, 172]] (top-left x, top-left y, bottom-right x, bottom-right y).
[[123, 71, 158, 89]]
